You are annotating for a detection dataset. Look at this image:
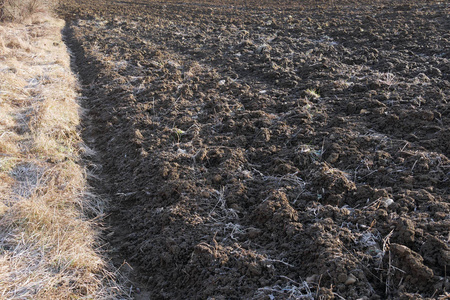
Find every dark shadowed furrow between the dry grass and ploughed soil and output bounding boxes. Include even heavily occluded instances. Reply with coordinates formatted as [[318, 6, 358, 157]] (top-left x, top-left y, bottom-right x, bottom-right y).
[[63, 20, 150, 300]]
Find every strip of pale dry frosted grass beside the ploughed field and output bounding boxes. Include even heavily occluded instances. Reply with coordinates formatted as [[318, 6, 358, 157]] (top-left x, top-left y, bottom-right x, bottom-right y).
[[0, 13, 123, 299]]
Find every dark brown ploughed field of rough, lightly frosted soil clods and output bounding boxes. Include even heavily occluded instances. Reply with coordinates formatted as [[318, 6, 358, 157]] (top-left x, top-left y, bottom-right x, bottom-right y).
[[61, 0, 450, 299]]
